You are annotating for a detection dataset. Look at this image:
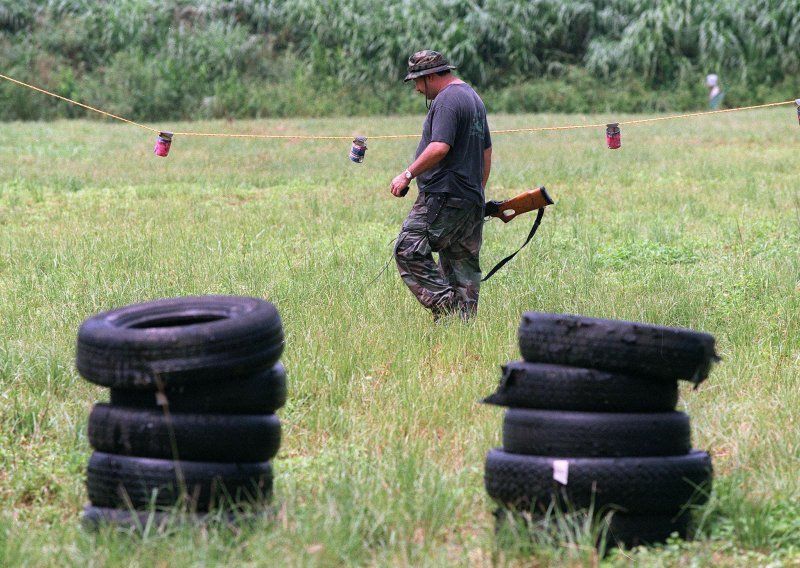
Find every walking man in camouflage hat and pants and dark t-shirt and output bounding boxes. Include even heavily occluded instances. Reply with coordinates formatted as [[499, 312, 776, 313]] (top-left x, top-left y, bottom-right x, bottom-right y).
[[391, 50, 492, 320]]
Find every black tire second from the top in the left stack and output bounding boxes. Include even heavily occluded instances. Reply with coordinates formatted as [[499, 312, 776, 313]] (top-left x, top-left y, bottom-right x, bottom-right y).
[[110, 363, 286, 414]]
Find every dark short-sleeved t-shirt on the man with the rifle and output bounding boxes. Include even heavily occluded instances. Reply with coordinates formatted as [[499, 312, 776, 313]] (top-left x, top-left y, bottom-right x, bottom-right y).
[[417, 83, 492, 205]]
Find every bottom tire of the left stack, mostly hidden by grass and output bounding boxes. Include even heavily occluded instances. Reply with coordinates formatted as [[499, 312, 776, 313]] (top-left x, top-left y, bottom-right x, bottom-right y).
[[81, 505, 273, 531]]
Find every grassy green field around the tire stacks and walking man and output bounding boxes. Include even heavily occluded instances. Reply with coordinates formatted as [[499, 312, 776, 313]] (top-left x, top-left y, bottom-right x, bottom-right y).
[[0, 108, 800, 567]]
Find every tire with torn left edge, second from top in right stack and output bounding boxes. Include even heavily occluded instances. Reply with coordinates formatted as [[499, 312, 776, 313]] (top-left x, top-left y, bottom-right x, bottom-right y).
[[483, 361, 678, 412]]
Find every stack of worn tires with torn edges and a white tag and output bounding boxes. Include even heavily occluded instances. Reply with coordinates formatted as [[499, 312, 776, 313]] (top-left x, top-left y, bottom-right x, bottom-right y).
[[484, 312, 719, 546]]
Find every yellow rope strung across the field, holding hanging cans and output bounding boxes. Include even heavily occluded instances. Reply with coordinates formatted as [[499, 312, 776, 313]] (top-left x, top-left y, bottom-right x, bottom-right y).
[[0, 74, 795, 140]]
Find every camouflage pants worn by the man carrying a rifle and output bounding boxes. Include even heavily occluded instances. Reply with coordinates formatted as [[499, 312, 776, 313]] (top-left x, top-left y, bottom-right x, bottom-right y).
[[394, 192, 483, 319]]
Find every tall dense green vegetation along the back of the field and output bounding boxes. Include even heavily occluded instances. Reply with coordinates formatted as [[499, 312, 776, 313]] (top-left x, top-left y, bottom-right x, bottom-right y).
[[0, 0, 800, 120]]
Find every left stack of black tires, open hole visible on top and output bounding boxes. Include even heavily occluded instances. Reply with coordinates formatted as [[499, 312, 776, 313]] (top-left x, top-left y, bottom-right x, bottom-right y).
[[76, 296, 286, 526]]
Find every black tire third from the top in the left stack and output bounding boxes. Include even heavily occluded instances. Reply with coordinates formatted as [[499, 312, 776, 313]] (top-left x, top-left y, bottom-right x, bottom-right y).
[[89, 403, 281, 462]]
